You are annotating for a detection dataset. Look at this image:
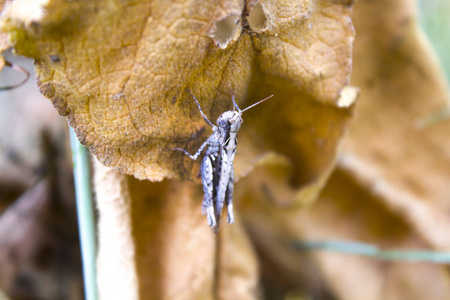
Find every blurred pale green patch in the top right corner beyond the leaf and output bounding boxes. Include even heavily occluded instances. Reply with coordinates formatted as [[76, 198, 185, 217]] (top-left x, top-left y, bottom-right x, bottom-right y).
[[418, 0, 450, 83]]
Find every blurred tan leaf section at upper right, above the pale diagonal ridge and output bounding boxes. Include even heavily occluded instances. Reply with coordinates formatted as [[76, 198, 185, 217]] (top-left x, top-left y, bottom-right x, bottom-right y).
[[342, 0, 450, 249]]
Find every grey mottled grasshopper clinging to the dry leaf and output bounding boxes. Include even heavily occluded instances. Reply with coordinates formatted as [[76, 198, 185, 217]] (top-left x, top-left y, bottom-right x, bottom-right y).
[[174, 93, 273, 233]]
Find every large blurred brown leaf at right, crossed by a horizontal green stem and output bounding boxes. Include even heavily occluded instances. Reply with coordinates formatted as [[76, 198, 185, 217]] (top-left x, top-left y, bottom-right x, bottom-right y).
[[237, 0, 450, 299]]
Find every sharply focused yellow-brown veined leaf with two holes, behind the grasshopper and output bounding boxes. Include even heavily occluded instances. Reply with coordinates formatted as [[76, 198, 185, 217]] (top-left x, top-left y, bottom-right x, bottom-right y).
[[3, 0, 354, 180]]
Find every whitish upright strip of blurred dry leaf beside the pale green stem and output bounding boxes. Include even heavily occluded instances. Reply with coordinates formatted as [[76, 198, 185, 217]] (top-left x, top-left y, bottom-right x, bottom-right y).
[[94, 161, 139, 300]]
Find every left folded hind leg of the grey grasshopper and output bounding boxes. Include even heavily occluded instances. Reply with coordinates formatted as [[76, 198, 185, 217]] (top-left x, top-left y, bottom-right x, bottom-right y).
[[200, 155, 217, 227]]
